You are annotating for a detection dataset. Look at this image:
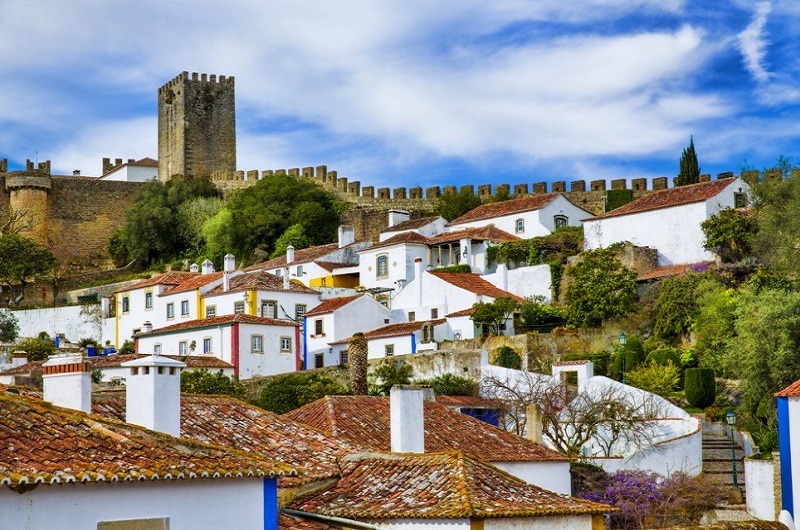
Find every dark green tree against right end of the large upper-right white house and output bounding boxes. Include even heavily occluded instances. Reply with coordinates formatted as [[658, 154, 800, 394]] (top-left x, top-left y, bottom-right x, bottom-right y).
[[700, 208, 758, 263]]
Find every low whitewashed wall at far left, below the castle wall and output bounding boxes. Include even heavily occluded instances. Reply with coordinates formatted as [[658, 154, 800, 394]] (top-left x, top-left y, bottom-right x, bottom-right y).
[[12, 304, 103, 344]]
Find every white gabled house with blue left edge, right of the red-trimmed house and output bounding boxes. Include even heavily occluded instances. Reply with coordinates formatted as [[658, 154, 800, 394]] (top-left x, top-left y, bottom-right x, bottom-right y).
[[303, 294, 389, 369]]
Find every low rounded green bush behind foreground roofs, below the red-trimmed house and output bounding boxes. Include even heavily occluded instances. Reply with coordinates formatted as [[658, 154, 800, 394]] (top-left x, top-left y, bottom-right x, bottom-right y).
[[254, 372, 349, 414]]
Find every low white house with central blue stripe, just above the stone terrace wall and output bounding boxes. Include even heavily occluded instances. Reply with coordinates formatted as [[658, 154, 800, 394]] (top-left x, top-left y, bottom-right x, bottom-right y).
[[332, 318, 450, 359]]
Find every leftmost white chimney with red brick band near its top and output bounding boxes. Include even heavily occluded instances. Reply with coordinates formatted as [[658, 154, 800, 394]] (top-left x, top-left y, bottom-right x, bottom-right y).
[[42, 354, 92, 413]]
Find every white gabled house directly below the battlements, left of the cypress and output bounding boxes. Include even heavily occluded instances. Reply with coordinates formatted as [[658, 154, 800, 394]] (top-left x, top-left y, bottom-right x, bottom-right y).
[[447, 193, 592, 235]]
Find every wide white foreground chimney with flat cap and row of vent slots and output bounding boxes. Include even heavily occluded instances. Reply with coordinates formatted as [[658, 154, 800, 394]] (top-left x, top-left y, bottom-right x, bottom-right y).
[[122, 355, 186, 436]]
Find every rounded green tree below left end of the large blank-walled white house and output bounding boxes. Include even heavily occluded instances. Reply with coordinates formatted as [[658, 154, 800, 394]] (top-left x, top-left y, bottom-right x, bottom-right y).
[[564, 249, 636, 327]]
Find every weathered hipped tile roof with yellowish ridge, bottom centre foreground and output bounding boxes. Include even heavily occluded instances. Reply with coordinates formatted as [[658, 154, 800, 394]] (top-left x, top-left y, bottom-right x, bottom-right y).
[[290, 448, 614, 519]]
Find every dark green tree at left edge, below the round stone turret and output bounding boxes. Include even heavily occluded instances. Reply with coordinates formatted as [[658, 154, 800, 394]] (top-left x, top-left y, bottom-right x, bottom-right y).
[[0, 233, 58, 293]]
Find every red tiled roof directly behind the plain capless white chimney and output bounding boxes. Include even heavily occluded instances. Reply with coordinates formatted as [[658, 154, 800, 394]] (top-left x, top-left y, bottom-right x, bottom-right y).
[[284, 396, 569, 462]]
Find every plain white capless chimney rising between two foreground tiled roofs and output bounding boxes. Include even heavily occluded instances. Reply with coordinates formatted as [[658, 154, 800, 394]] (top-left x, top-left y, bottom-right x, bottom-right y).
[[389, 385, 425, 453]]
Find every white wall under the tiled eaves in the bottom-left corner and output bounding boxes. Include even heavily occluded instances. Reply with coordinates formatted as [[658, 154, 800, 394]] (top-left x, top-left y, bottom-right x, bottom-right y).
[[0, 479, 277, 530]]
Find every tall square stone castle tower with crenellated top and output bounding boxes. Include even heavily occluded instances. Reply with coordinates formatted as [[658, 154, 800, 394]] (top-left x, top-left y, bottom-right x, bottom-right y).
[[158, 72, 236, 181]]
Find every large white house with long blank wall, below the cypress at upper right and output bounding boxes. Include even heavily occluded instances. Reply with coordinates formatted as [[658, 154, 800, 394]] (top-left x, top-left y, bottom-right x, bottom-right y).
[[583, 177, 750, 266]]
